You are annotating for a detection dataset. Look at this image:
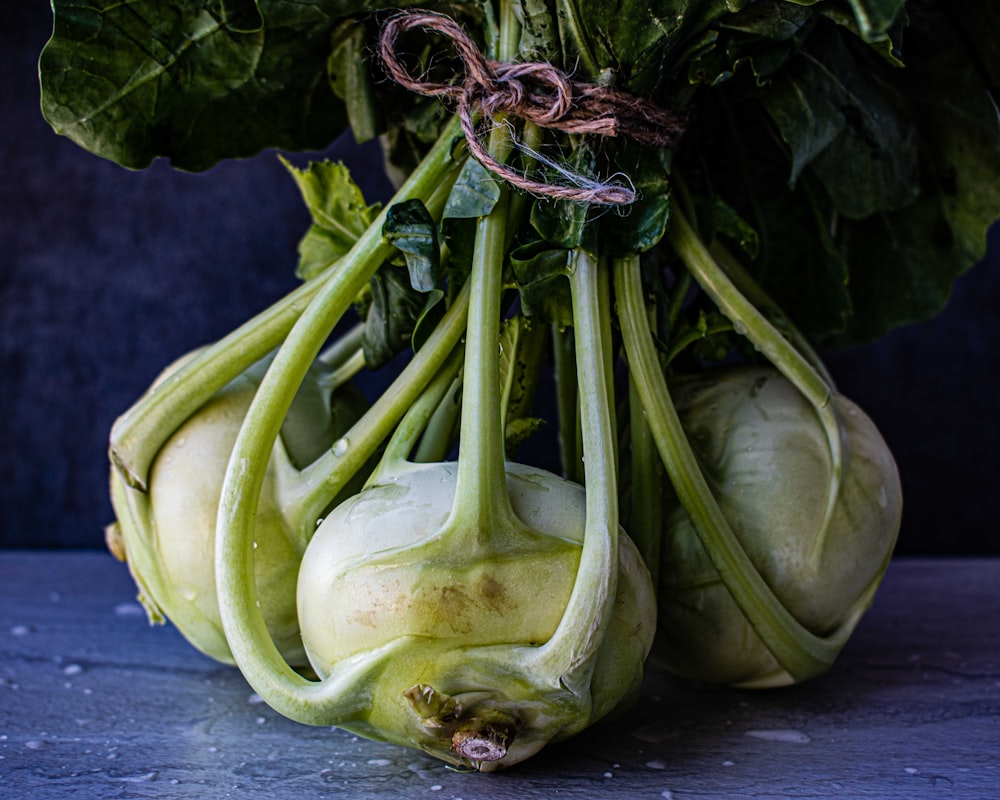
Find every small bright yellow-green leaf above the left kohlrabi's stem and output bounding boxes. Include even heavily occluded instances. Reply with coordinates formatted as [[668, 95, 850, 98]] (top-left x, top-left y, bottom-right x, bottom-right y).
[[279, 156, 381, 280]]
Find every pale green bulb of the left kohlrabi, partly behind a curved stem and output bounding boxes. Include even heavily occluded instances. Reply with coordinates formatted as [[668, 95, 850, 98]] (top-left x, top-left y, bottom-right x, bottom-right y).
[[111, 344, 366, 665]]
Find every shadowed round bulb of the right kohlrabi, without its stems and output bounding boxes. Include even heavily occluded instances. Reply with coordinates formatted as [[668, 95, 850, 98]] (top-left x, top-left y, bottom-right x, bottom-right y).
[[653, 367, 902, 686]]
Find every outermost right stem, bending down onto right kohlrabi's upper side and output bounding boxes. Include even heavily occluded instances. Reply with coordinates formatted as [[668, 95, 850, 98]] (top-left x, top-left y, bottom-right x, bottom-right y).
[[670, 204, 844, 560]]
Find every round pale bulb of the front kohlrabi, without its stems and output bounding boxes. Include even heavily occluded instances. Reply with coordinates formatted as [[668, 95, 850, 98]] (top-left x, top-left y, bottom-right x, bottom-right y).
[[298, 463, 655, 770]]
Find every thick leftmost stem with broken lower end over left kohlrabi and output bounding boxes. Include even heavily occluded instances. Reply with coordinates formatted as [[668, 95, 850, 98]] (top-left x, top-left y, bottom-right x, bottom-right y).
[[110, 119, 460, 491]]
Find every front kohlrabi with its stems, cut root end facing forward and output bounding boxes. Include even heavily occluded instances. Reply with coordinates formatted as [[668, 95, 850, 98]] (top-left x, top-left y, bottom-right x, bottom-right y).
[[217, 119, 655, 770]]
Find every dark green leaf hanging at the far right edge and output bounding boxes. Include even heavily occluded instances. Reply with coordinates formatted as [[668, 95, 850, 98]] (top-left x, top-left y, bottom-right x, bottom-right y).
[[842, 2, 1000, 341]]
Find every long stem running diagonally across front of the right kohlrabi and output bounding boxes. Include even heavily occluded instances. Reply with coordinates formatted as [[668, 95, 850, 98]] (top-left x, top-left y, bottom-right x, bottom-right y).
[[615, 257, 853, 680]]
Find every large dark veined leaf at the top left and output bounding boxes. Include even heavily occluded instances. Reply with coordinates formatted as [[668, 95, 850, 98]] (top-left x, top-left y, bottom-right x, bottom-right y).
[[40, 0, 358, 170]]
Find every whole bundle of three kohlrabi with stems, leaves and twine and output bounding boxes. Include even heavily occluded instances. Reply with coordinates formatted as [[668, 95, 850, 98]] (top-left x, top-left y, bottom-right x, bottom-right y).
[[40, 0, 1000, 769]]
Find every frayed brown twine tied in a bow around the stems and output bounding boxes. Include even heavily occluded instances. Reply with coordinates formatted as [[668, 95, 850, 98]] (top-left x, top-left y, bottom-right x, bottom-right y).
[[380, 11, 684, 205]]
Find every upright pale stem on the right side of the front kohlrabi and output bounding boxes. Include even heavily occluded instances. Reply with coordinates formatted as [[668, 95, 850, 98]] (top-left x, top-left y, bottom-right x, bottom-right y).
[[534, 250, 618, 697]]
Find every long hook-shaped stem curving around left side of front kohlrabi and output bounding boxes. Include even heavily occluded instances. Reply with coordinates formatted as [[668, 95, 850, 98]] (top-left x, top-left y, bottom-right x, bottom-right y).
[[215, 117, 468, 725]]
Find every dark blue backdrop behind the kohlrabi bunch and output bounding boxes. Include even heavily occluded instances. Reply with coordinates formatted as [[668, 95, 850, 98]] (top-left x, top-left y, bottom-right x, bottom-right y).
[[0, 6, 1000, 554]]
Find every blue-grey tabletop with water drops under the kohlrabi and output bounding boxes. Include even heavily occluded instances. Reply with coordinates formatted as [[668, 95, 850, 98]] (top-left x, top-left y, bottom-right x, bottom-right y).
[[0, 552, 1000, 800]]
